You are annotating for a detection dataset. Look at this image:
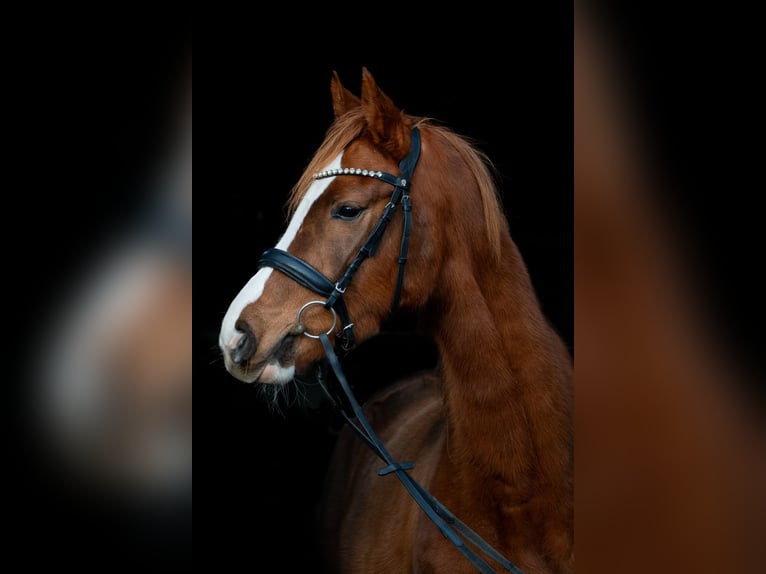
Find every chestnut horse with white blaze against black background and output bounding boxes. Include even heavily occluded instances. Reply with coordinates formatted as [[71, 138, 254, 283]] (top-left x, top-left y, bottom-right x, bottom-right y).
[[219, 67, 574, 573]]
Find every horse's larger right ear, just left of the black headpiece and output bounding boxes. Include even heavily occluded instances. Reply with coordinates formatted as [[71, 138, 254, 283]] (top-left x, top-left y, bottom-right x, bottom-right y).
[[362, 67, 412, 159]]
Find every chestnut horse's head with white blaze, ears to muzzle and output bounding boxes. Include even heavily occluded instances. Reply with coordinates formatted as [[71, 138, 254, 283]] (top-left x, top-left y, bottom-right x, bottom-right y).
[[219, 69, 441, 384]]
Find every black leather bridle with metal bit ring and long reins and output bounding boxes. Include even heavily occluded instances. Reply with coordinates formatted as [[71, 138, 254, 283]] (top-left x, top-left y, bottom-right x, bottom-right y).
[[258, 127, 523, 574]]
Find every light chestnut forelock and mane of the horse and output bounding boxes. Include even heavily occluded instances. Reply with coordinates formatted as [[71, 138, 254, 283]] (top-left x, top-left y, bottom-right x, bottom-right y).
[[287, 107, 506, 258]]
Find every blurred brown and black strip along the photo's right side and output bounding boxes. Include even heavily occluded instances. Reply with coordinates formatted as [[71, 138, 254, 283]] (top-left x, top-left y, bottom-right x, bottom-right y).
[[574, 2, 766, 573]]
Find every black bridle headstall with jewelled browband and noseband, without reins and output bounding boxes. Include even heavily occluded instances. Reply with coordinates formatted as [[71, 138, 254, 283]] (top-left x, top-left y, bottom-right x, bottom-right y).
[[258, 127, 420, 352]]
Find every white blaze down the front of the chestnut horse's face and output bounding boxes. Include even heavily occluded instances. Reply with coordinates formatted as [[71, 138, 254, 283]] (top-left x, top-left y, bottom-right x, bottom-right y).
[[218, 153, 343, 352]]
